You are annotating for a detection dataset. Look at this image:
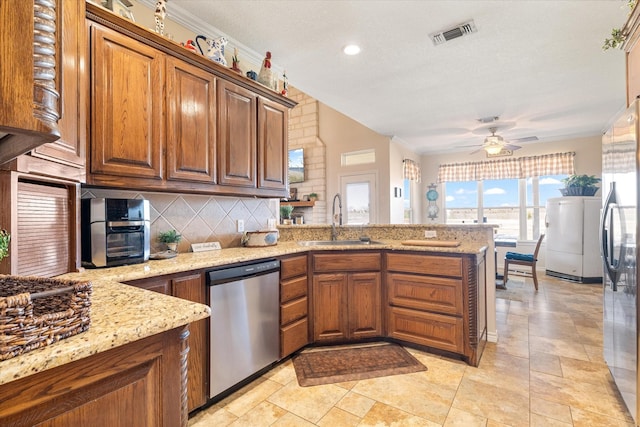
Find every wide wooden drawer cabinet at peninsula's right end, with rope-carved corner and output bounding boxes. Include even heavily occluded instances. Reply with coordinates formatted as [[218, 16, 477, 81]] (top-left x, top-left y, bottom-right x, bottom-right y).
[[386, 253, 487, 366]]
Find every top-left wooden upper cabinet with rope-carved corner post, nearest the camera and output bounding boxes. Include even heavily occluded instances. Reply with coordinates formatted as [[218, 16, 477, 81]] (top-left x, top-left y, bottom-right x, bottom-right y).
[[0, 0, 60, 164]]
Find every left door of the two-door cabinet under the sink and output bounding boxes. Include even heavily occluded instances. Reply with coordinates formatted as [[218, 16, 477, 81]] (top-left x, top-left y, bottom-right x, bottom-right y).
[[313, 274, 348, 341]]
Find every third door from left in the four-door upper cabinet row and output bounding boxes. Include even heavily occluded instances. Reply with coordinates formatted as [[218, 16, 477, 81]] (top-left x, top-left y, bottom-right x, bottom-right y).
[[218, 81, 258, 187]]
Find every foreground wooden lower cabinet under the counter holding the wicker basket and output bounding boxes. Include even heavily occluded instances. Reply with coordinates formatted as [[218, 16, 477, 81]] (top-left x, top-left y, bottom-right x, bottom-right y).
[[0, 326, 188, 427]]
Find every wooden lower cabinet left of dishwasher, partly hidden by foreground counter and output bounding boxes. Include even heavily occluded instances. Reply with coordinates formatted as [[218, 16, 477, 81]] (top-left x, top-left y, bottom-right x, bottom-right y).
[[128, 272, 209, 411]]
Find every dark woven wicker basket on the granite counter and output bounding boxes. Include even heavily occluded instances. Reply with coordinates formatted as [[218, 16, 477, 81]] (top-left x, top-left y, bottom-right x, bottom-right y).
[[0, 275, 92, 360]]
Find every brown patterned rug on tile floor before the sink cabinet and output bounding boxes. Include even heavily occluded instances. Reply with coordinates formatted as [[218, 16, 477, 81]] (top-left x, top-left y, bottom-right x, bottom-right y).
[[293, 343, 427, 387]]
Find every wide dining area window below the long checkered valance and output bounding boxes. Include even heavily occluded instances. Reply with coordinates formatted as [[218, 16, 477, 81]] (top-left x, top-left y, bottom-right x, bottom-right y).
[[445, 175, 567, 240]]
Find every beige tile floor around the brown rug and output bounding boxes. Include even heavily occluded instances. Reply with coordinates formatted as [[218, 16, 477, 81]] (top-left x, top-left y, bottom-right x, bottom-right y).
[[189, 275, 633, 427]]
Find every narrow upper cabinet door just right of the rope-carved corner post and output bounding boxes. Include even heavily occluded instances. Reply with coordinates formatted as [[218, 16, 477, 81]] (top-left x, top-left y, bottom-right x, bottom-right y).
[[31, 0, 88, 168]]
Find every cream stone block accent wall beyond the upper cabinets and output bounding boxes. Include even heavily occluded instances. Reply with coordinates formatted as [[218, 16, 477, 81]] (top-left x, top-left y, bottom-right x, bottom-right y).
[[289, 87, 327, 224]]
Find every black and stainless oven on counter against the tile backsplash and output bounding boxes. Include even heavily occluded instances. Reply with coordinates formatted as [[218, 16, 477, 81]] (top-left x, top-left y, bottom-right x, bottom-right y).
[[81, 198, 150, 267]]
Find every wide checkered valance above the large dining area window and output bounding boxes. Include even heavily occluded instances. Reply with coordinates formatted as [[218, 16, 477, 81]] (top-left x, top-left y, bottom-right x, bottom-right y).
[[438, 152, 576, 182]]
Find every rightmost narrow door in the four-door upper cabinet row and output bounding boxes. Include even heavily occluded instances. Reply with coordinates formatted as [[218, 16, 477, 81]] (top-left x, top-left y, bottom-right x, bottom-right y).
[[258, 98, 289, 190]]
